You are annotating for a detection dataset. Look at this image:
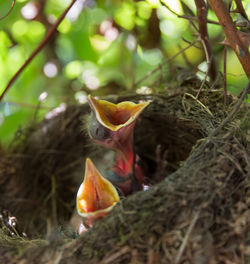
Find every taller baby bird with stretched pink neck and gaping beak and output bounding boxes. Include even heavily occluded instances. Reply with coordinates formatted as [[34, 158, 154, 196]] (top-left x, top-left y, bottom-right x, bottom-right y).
[[88, 95, 149, 196]]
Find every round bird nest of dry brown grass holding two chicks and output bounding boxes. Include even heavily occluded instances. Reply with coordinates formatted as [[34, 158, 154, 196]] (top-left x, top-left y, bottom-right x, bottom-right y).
[[0, 85, 250, 264]]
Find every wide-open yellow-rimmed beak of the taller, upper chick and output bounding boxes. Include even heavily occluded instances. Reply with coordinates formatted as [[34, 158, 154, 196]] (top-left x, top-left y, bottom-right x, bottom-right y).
[[88, 95, 149, 131]]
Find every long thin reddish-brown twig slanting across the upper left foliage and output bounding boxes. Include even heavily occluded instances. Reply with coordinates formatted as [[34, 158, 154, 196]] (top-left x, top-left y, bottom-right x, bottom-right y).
[[0, 0, 77, 101]]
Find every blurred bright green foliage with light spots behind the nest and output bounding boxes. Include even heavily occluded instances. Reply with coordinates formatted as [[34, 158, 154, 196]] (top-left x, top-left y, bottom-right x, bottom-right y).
[[0, 0, 250, 145]]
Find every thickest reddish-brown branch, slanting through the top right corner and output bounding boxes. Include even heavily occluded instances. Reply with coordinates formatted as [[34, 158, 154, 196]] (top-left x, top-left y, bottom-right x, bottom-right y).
[[209, 0, 250, 78]]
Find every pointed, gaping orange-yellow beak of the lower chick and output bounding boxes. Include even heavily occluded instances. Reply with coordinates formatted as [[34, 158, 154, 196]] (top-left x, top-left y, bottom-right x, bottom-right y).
[[76, 158, 120, 226]]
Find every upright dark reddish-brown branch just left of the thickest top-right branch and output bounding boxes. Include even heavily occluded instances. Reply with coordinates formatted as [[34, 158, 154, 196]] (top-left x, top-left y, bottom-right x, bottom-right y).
[[195, 0, 217, 81]]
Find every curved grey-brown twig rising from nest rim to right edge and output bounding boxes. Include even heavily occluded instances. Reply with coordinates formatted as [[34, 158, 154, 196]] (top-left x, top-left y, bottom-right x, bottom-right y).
[[209, 79, 250, 137]]
